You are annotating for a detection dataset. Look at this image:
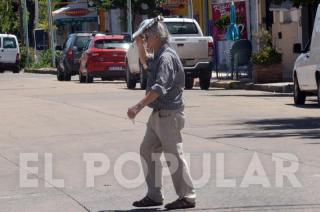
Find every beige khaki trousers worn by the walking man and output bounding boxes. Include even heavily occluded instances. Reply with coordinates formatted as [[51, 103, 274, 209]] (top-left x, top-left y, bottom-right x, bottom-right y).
[[140, 109, 196, 202]]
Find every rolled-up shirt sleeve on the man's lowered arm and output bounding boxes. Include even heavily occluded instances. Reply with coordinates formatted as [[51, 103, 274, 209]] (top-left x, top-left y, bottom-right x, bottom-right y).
[[151, 59, 175, 96]]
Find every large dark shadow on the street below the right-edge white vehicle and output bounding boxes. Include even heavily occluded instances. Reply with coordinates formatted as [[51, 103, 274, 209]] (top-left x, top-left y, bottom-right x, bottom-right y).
[[208, 117, 320, 139]]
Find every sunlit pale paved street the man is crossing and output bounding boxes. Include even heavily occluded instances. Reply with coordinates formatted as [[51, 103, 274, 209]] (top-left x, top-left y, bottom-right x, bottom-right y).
[[0, 73, 320, 212]]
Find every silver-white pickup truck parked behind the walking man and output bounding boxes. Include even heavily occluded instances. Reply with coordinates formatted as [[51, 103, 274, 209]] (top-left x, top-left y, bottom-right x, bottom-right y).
[[126, 18, 213, 89]]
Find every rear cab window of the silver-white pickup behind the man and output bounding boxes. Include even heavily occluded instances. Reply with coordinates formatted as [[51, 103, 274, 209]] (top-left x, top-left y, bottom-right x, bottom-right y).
[[165, 22, 198, 35]]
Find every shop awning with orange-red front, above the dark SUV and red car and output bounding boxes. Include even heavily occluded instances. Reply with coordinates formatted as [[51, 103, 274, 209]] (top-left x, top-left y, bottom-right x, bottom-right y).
[[52, 3, 98, 25]]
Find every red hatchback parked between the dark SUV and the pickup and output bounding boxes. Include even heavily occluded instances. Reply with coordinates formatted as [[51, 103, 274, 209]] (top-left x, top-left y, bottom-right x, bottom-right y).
[[79, 34, 130, 83]]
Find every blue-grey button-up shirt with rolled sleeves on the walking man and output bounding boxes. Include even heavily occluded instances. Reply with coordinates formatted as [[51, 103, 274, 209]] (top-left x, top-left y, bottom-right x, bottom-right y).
[[147, 44, 185, 110]]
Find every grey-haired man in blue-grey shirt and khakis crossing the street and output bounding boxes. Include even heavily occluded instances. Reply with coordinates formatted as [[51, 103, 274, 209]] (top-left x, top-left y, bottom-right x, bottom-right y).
[[127, 18, 196, 209]]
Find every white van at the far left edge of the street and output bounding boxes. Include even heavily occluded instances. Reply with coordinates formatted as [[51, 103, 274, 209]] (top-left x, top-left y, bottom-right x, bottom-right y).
[[0, 34, 20, 73]]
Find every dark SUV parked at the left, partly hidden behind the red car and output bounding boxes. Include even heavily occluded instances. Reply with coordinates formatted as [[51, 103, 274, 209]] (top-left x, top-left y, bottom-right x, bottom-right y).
[[56, 33, 92, 81]]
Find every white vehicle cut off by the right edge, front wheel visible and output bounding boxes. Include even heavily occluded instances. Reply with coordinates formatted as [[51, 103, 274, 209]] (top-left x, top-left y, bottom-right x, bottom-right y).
[[293, 4, 320, 105]]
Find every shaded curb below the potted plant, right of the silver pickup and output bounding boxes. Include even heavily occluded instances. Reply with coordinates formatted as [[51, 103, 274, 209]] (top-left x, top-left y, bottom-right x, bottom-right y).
[[195, 80, 293, 93]]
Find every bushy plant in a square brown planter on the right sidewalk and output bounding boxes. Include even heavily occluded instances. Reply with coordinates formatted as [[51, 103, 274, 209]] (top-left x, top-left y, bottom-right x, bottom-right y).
[[251, 30, 282, 83]]
